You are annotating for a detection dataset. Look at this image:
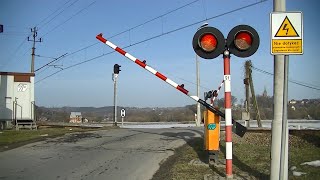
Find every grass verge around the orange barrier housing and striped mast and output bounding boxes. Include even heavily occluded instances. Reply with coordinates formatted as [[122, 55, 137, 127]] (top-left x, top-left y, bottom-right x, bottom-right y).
[[153, 131, 320, 180]]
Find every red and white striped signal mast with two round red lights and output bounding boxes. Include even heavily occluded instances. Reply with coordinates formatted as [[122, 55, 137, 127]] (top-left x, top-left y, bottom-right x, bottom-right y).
[[192, 25, 260, 178]]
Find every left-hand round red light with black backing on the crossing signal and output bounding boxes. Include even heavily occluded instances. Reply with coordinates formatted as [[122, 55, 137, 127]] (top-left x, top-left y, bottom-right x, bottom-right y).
[[192, 26, 225, 59]]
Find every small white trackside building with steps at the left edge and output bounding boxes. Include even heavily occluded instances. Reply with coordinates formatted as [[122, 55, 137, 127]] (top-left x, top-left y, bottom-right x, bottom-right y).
[[0, 72, 36, 129]]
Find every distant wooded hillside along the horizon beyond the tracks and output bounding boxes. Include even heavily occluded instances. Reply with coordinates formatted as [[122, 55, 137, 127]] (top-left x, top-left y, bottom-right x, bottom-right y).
[[37, 95, 320, 122]]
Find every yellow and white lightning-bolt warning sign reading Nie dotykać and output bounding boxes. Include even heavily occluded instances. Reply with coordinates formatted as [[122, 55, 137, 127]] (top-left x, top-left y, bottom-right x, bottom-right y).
[[270, 12, 303, 55]]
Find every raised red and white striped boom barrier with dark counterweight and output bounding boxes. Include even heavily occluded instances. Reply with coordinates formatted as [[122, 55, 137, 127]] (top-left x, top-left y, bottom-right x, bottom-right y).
[[96, 34, 247, 137]]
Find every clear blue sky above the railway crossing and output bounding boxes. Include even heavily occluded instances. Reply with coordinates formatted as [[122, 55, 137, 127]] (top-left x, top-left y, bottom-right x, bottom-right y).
[[0, 0, 320, 107]]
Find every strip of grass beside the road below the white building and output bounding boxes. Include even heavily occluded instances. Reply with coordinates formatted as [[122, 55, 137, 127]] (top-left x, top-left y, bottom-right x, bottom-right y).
[[0, 127, 114, 152]]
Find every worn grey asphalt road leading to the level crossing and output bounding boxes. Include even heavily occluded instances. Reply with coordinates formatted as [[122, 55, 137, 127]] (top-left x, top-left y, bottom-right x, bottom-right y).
[[0, 127, 203, 180]]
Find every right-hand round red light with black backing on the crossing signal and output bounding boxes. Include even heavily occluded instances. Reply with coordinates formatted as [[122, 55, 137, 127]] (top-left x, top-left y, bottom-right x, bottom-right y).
[[227, 25, 260, 57]]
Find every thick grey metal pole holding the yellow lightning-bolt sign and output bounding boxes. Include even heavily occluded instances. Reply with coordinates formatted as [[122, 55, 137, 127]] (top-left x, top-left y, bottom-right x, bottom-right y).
[[270, 0, 288, 180]]
